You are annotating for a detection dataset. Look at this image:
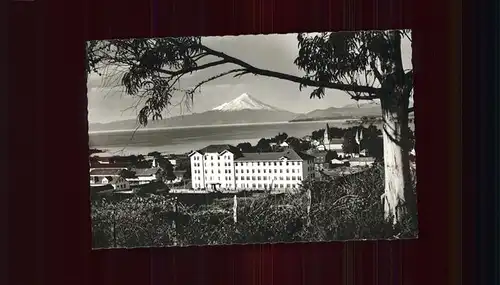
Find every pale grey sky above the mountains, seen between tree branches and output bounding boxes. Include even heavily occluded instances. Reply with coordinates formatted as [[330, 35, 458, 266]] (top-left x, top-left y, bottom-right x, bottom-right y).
[[87, 31, 412, 123]]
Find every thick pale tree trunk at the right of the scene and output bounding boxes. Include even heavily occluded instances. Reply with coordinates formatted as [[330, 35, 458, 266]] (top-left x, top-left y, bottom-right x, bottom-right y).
[[381, 88, 417, 225]]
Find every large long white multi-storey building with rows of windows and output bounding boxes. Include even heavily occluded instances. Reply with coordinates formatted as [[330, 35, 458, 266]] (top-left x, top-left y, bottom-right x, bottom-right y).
[[189, 145, 314, 190]]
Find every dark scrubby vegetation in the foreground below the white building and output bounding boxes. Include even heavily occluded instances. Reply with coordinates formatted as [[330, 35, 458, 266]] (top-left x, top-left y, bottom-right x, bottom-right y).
[[92, 163, 418, 248]]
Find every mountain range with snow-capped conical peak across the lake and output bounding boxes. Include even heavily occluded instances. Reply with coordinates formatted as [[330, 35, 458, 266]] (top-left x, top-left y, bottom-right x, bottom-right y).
[[89, 93, 381, 132]]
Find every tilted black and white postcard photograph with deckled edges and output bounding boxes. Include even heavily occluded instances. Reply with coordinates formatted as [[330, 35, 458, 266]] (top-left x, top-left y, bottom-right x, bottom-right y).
[[85, 30, 418, 249]]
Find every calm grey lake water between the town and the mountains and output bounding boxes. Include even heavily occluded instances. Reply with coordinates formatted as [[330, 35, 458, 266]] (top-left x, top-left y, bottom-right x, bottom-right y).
[[89, 120, 398, 155]]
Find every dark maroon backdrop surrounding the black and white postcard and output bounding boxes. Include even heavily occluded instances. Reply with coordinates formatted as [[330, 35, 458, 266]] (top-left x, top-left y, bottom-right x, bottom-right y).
[[6, 0, 464, 285]]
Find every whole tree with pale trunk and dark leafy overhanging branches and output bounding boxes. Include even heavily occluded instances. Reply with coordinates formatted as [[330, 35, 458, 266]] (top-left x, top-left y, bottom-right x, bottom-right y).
[[86, 30, 416, 224]]
